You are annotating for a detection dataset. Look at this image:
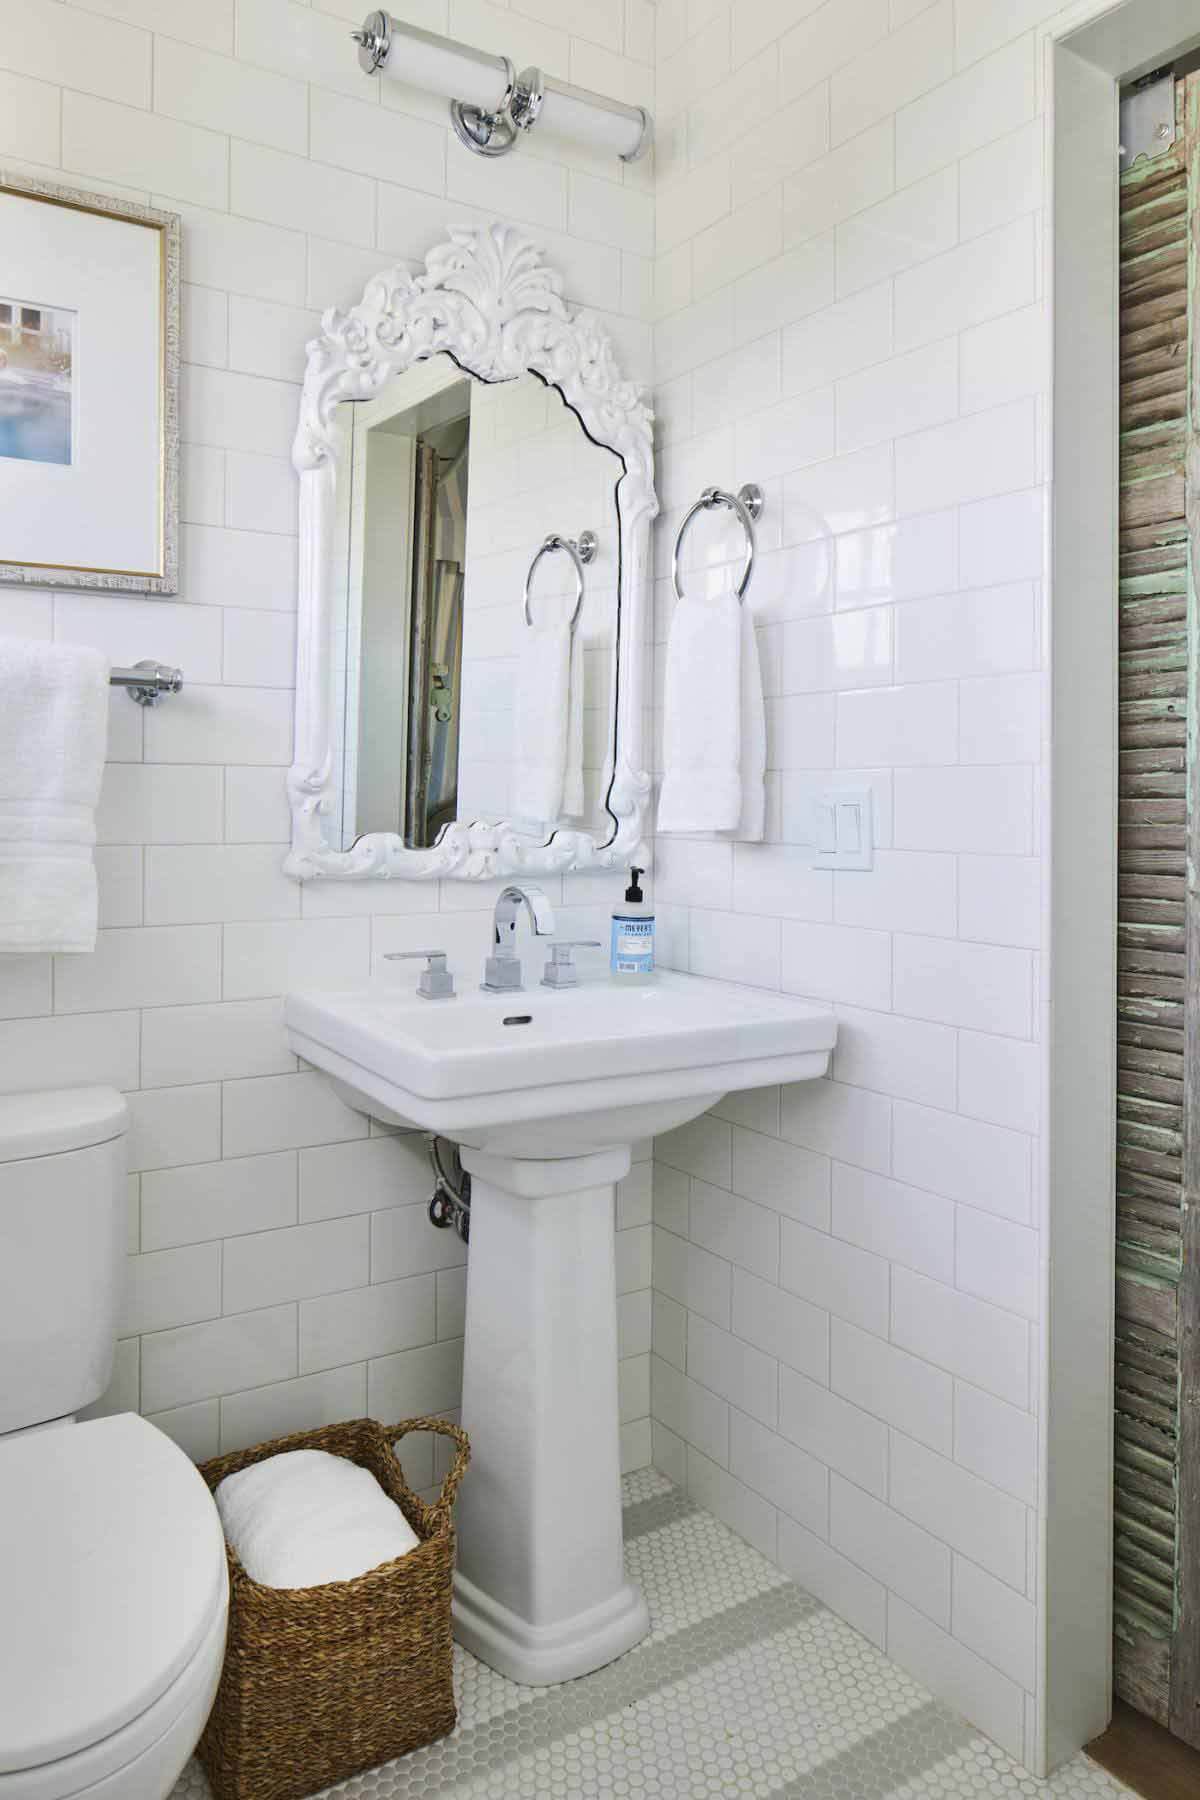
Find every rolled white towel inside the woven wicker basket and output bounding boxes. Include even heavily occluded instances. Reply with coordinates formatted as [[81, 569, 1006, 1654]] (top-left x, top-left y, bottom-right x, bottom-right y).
[[216, 1451, 421, 1588]]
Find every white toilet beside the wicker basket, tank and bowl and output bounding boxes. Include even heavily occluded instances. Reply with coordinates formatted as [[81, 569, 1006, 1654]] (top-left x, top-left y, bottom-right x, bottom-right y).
[[0, 1087, 228, 1800]]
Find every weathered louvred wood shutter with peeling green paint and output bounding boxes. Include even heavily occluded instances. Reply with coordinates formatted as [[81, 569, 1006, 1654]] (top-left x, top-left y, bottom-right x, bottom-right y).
[[1114, 77, 1200, 1744]]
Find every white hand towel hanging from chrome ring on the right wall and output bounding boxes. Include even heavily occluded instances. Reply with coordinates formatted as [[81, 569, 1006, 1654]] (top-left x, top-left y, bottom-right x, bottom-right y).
[[658, 576, 766, 841]]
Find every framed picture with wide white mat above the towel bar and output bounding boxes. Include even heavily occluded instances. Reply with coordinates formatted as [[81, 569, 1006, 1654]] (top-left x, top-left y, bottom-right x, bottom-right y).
[[0, 169, 180, 594]]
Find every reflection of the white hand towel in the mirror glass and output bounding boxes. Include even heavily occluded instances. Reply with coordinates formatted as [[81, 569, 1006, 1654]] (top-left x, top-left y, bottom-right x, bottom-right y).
[[513, 623, 583, 826]]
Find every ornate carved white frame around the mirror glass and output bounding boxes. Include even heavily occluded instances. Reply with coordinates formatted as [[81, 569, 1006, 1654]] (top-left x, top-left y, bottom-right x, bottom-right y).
[[284, 223, 658, 880]]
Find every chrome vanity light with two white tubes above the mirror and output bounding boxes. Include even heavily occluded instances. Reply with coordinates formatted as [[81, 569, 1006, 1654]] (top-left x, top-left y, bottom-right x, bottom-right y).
[[351, 13, 653, 162]]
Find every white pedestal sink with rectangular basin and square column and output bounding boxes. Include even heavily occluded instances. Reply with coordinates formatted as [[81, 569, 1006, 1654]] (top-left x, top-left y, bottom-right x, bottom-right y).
[[286, 974, 837, 1685]]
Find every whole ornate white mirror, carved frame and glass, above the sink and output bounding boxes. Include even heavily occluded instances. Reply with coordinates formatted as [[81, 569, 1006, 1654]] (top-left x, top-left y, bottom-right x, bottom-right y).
[[284, 223, 657, 880]]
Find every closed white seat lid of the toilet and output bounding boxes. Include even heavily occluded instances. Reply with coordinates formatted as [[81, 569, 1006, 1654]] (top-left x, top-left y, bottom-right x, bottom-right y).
[[0, 1413, 225, 1773]]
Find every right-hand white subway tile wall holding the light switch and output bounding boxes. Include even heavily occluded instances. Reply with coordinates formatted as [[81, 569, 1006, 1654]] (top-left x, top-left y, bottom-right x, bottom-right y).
[[651, 0, 1060, 1762]]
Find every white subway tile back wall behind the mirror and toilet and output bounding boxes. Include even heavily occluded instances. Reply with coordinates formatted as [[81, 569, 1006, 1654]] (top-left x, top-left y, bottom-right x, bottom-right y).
[[18, 0, 651, 1485]]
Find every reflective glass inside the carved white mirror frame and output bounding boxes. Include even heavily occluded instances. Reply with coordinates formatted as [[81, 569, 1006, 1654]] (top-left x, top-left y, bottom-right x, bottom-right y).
[[333, 356, 622, 850]]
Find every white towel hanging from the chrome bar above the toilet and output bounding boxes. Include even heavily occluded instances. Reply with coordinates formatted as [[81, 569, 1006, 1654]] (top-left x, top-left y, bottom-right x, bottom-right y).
[[0, 637, 108, 950]]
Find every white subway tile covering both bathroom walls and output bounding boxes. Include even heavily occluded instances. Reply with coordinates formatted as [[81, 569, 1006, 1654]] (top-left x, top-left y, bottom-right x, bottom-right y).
[[0, 0, 1086, 1762]]
